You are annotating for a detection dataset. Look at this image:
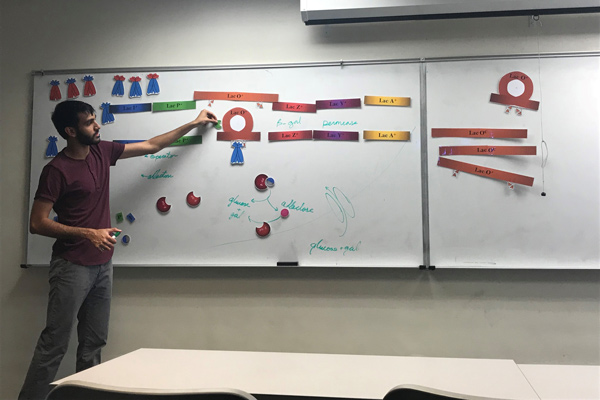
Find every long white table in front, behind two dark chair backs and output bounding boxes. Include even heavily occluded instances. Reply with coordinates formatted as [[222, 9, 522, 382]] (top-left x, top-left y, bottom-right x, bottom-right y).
[[54, 349, 538, 400]]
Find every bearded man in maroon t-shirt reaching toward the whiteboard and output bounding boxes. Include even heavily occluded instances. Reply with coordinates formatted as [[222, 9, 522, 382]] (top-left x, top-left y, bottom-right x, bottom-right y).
[[19, 100, 218, 400]]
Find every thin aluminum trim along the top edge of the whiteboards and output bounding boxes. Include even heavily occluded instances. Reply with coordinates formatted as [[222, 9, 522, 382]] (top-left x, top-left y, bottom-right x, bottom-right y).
[[31, 51, 600, 76]]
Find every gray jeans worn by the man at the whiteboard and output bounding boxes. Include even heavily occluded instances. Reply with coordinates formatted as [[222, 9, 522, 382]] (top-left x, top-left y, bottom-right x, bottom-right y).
[[19, 258, 113, 400]]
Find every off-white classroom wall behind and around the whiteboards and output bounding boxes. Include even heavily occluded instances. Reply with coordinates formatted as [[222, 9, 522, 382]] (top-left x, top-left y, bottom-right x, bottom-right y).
[[0, 0, 600, 399]]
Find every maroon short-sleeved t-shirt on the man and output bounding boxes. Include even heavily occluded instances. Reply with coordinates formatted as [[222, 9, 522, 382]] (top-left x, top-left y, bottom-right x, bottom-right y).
[[34, 141, 125, 265]]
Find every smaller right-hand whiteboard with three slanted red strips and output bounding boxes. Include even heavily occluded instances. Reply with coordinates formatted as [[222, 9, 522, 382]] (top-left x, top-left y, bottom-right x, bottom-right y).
[[427, 57, 600, 268]]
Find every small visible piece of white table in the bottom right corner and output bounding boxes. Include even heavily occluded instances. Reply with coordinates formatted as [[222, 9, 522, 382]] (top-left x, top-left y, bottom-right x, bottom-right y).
[[519, 364, 600, 400]]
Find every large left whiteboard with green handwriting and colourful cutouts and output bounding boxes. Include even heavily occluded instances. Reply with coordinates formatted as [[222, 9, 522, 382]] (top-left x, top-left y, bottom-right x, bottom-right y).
[[27, 63, 423, 267]]
